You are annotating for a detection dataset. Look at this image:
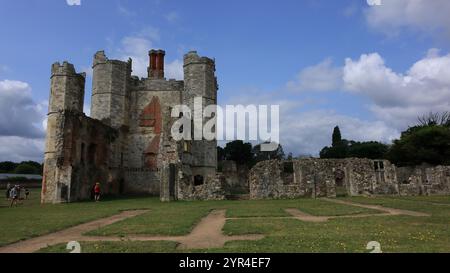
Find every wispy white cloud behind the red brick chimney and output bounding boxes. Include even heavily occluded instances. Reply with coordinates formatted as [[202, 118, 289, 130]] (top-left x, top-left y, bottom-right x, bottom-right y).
[[113, 27, 183, 80]]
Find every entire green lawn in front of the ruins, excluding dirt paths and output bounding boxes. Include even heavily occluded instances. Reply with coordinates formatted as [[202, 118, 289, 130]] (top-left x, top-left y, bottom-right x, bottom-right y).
[[0, 188, 450, 253]]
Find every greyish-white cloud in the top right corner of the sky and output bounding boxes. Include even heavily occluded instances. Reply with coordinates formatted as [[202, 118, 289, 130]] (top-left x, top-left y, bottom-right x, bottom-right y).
[[365, 0, 450, 38]]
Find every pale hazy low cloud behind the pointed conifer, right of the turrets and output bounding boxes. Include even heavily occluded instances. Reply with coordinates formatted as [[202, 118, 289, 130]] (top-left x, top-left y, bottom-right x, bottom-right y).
[[222, 89, 400, 156]]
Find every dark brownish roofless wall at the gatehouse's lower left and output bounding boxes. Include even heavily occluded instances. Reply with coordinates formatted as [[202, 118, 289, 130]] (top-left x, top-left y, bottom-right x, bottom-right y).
[[42, 111, 120, 203]]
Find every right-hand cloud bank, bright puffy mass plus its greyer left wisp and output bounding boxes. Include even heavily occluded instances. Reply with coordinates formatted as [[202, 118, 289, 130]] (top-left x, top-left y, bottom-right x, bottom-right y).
[[287, 49, 450, 130]]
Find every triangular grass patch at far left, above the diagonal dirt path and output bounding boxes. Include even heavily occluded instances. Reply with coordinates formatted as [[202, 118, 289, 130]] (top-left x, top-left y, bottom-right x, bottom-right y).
[[0, 190, 159, 246]]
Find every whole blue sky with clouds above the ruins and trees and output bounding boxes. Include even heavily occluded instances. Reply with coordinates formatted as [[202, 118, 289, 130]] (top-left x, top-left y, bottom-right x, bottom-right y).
[[0, 0, 450, 160]]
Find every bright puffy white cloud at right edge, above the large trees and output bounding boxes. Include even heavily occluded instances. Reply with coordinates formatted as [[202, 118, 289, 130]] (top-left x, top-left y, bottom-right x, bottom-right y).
[[343, 49, 450, 129]]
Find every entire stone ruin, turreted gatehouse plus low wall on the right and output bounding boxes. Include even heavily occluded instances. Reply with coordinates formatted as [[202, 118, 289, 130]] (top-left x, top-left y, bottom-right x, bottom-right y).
[[42, 50, 450, 203]]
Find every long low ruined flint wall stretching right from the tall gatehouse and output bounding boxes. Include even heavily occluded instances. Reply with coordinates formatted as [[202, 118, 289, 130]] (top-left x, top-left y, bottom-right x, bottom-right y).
[[249, 158, 450, 199]]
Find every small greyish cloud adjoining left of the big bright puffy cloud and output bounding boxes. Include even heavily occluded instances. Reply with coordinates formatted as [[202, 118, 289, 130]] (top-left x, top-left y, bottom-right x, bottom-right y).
[[287, 59, 342, 91]]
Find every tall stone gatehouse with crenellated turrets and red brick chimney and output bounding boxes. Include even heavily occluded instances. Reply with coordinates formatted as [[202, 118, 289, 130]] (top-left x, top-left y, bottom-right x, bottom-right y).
[[42, 50, 224, 203]]
